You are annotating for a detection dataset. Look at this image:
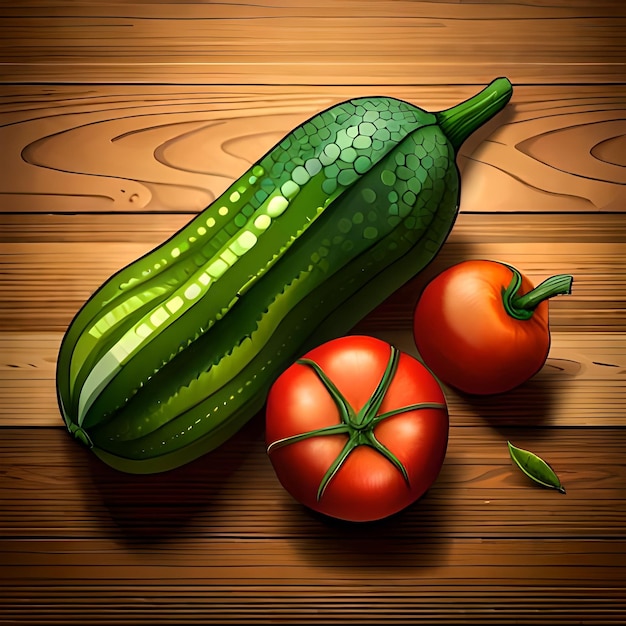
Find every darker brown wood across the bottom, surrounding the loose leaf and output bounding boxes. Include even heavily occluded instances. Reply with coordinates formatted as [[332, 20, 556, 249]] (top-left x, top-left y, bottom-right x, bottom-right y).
[[0, 420, 626, 623]]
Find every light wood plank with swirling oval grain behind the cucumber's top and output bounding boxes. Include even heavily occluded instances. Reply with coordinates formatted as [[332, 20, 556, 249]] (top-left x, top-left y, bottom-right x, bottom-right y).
[[0, 84, 626, 213]]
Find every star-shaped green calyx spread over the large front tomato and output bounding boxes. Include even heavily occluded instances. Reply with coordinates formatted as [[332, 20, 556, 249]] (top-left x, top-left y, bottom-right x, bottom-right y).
[[267, 346, 445, 502]]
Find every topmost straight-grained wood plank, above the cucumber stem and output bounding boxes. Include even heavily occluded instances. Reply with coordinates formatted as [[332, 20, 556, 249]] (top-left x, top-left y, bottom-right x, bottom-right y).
[[0, 0, 625, 85]]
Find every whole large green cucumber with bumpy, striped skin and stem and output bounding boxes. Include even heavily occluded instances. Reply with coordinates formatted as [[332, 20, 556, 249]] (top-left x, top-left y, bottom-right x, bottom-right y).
[[57, 78, 512, 473]]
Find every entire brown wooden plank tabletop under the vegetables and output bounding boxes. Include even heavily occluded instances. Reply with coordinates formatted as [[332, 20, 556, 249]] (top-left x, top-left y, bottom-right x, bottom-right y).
[[0, 0, 626, 624]]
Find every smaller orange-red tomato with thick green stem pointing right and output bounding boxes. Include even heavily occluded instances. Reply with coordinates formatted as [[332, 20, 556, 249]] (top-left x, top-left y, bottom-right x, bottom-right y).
[[413, 259, 573, 395]]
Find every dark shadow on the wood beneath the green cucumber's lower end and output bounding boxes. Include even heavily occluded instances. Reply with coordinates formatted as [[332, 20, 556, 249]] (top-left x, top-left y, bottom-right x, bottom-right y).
[[83, 414, 263, 545]]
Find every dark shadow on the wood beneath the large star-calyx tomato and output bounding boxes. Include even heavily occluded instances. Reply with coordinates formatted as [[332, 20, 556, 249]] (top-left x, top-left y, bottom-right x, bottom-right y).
[[289, 462, 459, 571]]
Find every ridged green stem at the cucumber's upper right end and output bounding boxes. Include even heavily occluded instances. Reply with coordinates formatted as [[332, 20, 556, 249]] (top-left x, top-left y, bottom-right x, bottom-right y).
[[435, 77, 513, 151]]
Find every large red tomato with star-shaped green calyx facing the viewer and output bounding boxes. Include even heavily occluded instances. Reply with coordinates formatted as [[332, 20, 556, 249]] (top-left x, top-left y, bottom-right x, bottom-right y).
[[266, 335, 449, 522]]
